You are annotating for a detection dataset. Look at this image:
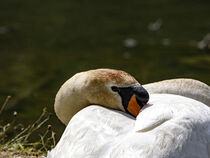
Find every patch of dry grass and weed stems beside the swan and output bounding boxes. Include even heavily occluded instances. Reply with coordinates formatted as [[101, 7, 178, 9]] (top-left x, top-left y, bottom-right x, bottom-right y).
[[0, 96, 55, 158]]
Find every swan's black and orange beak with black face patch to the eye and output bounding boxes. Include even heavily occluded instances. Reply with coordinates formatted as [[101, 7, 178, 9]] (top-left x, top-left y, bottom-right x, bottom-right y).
[[112, 84, 149, 117]]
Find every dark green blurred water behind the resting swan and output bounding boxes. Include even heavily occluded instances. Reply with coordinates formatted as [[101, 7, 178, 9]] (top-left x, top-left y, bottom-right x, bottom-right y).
[[0, 0, 210, 139]]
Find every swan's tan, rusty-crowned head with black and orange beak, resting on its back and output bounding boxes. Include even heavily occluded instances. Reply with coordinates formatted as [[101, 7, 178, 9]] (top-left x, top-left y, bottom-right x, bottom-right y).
[[54, 69, 149, 125]]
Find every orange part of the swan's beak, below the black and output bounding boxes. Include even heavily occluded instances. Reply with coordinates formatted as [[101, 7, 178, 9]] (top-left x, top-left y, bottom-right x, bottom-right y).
[[127, 94, 146, 117]]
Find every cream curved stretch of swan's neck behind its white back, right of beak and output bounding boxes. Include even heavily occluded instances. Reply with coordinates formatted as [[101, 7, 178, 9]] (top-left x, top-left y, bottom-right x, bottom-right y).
[[143, 79, 210, 107]]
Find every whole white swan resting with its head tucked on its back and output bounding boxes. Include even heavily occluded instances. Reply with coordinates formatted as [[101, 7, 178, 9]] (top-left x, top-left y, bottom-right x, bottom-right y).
[[47, 69, 210, 158]]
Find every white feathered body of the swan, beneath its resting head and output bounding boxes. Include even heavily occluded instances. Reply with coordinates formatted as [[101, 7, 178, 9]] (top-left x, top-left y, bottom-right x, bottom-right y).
[[48, 94, 210, 158]]
